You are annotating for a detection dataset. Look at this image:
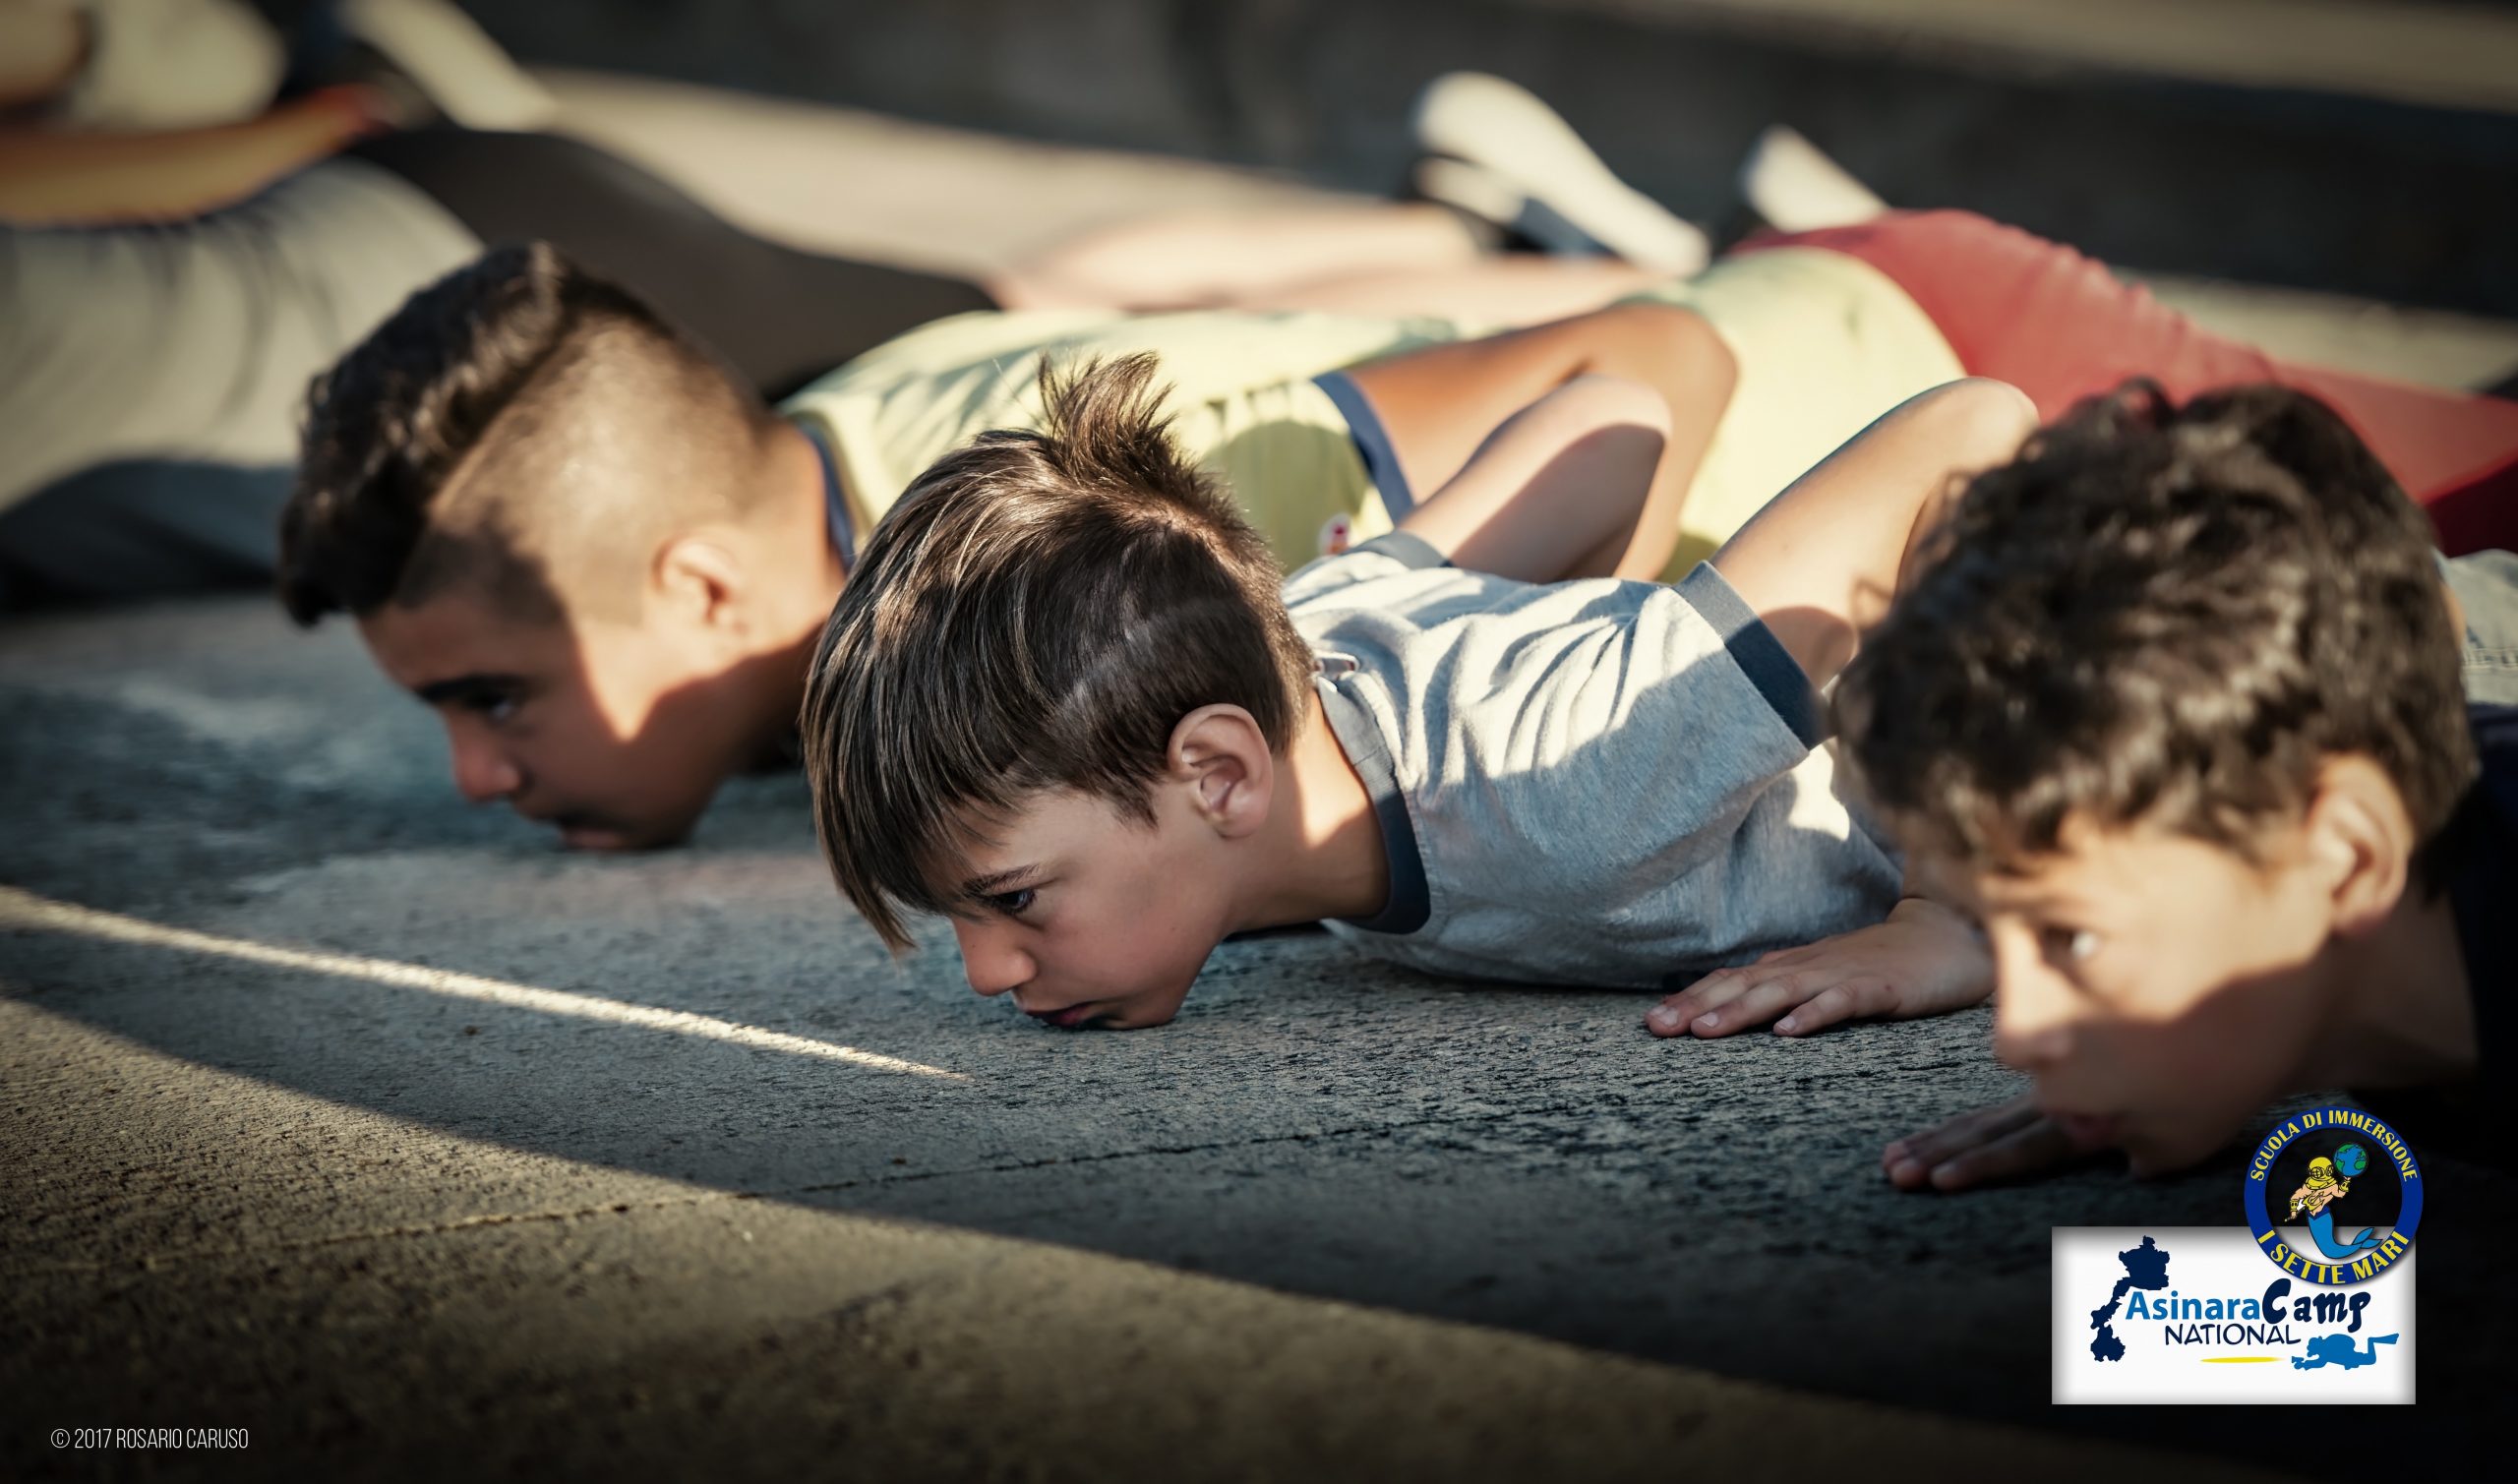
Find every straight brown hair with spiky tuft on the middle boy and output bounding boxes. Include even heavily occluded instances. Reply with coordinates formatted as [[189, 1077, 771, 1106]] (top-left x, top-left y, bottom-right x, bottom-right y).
[[804, 355, 1312, 950]]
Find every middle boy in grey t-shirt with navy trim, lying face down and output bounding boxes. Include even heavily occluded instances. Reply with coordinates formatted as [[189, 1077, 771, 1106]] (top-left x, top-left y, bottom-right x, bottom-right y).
[[804, 358, 2034, 1028]]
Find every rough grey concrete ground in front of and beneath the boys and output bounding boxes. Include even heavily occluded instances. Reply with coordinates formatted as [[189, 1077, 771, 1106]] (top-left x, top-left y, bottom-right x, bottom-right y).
[[0, 81, 2518, 1481]]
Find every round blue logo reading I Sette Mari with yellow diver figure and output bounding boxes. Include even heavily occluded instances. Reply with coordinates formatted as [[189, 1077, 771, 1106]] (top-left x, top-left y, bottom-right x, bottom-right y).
[[2247, 1106, 2423, 1287]]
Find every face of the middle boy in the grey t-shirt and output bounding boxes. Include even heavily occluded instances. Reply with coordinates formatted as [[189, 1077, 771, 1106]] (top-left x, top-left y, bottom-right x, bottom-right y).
[[941, 784, 1231, 1031]]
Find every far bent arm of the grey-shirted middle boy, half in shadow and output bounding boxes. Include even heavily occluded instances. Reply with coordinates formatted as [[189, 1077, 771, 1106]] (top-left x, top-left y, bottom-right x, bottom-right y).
[[1400, 376, 1677, 582]]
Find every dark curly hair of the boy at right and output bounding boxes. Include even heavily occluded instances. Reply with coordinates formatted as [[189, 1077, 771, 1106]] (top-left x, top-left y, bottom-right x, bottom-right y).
[[1835, 383, 2475, 869]]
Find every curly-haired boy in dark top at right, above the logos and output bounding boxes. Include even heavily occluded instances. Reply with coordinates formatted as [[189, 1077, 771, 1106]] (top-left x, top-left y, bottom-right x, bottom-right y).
[[1732, 388, 2518, 1189]]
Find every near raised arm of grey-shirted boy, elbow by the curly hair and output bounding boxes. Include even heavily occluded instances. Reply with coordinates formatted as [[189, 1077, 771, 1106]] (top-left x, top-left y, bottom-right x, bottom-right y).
[[1712, 381, 2037, 685]]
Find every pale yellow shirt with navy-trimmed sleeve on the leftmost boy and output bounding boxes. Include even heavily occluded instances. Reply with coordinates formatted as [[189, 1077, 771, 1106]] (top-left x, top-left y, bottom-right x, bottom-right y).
[[783, 247, 1961, 579]]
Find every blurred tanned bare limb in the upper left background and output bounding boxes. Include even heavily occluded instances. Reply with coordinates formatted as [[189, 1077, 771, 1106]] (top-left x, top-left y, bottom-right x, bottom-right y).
[[0, 89, 378, 227]]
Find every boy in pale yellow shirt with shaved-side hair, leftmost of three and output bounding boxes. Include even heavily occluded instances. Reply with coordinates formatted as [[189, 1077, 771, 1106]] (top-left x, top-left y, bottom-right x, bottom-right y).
[[279, 247, 1732, 849]]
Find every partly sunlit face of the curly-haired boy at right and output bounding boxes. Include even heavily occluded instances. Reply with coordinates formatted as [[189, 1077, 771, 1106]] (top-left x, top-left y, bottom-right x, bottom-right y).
[[1924, 821, 2332, 1174]]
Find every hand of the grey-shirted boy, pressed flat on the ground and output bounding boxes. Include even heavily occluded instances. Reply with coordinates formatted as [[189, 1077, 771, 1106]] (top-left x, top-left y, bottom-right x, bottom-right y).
[[1645, 897, 1995, 1036]]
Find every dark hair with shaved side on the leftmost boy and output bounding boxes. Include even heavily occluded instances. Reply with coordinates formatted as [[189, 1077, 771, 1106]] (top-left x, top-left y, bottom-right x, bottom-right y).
[[279, 242, 765, 624]]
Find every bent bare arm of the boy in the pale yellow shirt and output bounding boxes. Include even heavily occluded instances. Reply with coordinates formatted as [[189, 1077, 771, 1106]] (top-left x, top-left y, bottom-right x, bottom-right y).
[[1348, 305, 1735, 577]]
